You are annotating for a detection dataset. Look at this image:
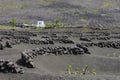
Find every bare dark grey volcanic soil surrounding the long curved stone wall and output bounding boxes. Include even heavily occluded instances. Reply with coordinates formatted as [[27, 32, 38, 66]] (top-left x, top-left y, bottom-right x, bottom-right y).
[[0, 29, 120, 80]]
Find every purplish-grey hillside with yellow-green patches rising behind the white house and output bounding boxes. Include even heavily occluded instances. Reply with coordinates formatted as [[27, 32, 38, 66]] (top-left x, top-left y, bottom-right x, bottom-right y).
[[0, 0, 120, 26]]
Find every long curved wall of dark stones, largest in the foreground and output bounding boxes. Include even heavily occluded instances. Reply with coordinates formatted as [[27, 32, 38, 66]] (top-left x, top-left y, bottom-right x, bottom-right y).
[[21, 45, 90, 68]]
